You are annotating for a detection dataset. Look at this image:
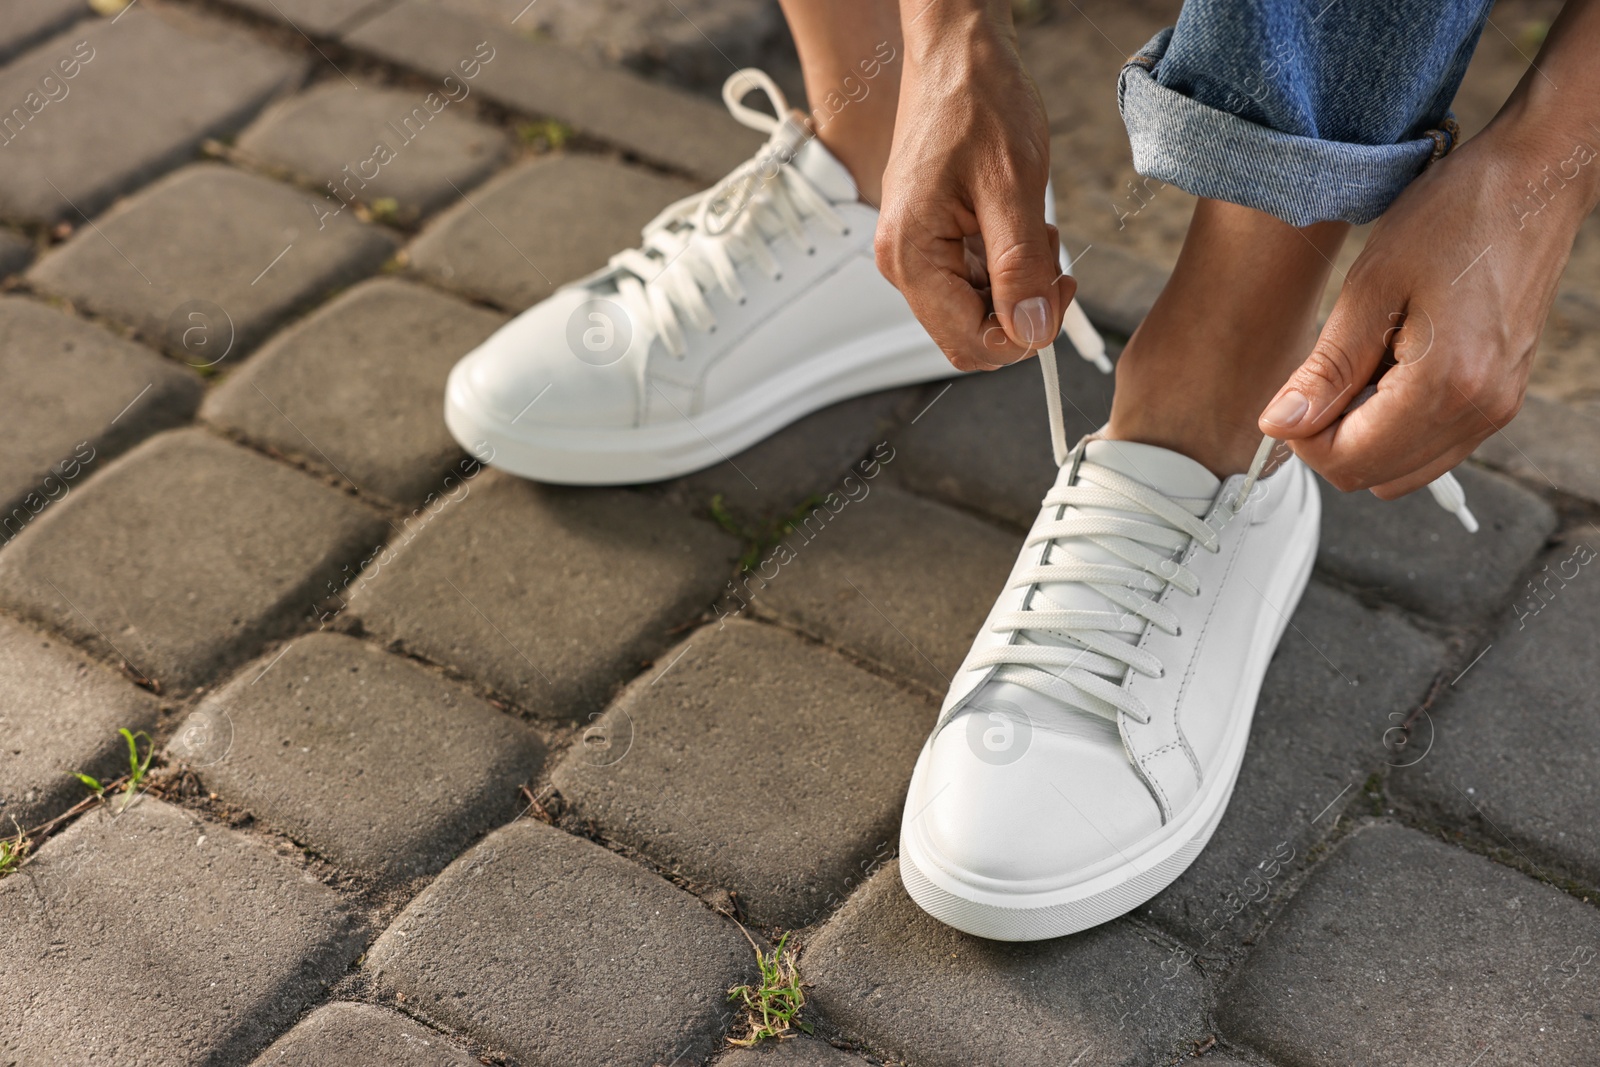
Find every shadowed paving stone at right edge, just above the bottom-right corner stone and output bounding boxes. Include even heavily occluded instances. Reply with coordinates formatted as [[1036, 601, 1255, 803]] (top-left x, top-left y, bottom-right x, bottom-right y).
[[1390, 528, 1600, 885]]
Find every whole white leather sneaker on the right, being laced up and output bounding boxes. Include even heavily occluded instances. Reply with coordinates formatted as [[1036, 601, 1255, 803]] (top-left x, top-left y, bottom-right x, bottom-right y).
[[901, 404, 1320, 941]]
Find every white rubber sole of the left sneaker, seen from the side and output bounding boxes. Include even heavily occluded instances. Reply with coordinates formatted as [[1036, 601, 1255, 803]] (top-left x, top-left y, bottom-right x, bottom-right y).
[[445, 316, 960, 485]]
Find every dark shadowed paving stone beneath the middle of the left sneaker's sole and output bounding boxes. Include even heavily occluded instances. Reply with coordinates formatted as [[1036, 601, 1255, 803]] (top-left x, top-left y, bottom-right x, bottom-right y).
[[662, 389, 922, 530]]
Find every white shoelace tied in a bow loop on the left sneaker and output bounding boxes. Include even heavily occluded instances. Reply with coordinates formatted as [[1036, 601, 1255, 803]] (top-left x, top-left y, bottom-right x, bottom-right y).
[[611, 67, 850, 384]]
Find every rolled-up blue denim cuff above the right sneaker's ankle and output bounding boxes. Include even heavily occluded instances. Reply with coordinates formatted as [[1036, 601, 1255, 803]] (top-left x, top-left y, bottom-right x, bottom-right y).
[[1117, 29, 1454, 226]]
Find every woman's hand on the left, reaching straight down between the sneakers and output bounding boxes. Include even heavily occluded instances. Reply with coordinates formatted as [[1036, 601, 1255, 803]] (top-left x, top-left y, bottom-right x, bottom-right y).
[[875, 0, 1075, 371]]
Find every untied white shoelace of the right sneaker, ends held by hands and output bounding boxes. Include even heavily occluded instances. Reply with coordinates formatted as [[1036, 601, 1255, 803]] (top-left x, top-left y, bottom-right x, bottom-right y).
[[970, 346, 1477, 723]]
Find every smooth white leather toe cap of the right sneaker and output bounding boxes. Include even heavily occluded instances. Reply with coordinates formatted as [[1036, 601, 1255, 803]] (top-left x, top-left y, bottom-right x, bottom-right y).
[[907, 712, 1162, 883]]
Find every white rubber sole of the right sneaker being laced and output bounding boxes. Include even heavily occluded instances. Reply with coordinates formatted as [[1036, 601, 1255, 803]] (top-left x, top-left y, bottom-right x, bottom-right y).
[[899, 486, 1322, 941]]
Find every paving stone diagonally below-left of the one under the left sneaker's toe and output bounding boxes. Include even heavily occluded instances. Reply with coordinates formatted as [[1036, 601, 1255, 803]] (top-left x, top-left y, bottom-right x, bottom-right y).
[[171, 633, 544, 881]]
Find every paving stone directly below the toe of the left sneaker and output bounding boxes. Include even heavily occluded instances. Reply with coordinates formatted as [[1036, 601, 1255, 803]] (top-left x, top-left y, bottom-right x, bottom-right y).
[[350, 472, 736, 720]]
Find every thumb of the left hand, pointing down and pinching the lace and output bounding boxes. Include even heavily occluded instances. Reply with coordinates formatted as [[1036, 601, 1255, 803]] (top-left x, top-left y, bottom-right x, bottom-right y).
[[978, 190, 1072, 355]]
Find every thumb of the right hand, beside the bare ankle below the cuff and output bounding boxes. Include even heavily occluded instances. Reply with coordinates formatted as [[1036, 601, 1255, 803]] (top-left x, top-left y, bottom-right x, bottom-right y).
[[1259, 288, 1394, 442]]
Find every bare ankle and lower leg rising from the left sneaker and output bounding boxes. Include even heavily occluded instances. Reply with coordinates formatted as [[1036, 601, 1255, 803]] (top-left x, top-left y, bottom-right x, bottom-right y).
[[782, 0, 906, 205]]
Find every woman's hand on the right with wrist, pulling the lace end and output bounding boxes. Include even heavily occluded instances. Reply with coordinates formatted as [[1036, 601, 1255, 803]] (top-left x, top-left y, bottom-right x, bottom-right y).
[[1261, 3, 1600, 499]]
